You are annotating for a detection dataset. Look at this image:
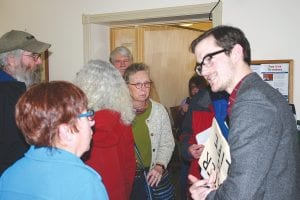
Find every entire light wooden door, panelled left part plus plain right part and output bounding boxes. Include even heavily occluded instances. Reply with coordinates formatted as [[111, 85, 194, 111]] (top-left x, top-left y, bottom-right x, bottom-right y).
[[111, 25, 211, 108]]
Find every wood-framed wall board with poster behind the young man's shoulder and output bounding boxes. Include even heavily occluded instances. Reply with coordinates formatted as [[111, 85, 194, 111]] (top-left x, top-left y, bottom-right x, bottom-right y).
[[251, 60, 293, 103]]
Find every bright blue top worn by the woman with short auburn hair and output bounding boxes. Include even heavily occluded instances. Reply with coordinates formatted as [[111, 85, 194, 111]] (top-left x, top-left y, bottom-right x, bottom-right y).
[[0, 146, 108, 200]]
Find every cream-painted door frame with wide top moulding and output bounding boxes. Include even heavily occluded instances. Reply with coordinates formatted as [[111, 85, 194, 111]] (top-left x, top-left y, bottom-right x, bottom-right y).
[[82, 2, 222, 63]]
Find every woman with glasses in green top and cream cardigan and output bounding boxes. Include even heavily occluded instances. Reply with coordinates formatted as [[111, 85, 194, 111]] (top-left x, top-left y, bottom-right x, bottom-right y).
[[124, 63, 175, 200]]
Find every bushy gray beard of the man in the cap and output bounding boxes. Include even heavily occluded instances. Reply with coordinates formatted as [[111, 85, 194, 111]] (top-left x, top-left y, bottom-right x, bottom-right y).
[[14, 65, 41, 88]]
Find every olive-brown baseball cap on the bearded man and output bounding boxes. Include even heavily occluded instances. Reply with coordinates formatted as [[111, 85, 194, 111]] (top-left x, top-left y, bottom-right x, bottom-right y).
[[0, 30, 51, 53]]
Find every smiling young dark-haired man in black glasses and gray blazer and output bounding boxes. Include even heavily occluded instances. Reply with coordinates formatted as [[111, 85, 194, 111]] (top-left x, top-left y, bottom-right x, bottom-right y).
[[189, 26, 300, 200]]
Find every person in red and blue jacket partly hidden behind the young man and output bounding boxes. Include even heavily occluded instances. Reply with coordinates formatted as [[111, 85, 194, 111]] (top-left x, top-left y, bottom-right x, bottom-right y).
[[180, 77, 228, 198]]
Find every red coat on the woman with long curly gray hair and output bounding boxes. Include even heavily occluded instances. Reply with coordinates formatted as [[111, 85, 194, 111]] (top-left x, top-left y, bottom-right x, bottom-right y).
[[86, 110, 136, 200]]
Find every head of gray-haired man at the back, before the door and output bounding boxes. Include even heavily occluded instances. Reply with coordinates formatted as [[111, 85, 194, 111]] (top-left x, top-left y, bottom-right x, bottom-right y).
[[109, 46, 133, 76]]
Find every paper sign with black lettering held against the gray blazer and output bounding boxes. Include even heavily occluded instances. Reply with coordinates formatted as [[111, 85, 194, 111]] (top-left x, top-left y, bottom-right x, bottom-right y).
[[198, 118, 231, 187]]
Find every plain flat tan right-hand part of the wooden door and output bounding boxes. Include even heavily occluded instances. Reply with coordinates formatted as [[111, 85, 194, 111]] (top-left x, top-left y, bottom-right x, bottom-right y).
[[144, 27, 199, 107]]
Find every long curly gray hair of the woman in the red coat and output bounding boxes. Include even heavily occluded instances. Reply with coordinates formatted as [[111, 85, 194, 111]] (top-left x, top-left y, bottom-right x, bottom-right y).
[[73, 60, 135, 124]]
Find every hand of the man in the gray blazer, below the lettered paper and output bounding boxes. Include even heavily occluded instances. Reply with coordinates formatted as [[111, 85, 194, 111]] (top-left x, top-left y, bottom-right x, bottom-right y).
[[188, 171, 217, 200]]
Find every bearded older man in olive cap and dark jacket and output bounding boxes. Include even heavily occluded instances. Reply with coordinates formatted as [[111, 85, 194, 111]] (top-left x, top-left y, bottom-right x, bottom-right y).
[[0, 30, 51, 176]]
